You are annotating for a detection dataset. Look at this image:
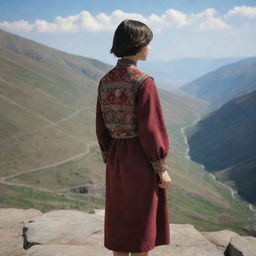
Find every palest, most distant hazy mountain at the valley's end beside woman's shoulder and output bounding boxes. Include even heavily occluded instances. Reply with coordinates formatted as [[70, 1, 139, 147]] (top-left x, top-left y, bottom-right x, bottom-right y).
[[140, 57, 243, 90]]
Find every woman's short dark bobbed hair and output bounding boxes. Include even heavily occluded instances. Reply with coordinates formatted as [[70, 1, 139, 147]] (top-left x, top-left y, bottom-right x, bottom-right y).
[[110, 19, 153, 57]]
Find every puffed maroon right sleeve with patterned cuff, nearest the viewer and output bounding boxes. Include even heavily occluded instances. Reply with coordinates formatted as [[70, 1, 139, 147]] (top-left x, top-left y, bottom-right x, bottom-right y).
[[136, 77, 169, 173]]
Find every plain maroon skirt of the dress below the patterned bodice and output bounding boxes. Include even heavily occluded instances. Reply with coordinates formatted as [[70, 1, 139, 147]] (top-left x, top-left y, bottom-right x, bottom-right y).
[[104, 136, 170, 252]]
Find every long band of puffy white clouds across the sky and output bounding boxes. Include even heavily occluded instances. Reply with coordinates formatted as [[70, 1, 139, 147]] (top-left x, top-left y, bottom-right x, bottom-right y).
[[0, 6, 256, 33]]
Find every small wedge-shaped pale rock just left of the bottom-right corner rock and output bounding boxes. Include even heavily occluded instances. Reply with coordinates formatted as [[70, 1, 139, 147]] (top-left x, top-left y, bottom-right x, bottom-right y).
[[201, 230, 240, 252]]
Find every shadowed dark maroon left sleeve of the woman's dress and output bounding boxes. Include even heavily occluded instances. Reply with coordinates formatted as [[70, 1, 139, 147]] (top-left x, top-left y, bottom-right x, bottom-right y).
[[96, 84, 111, 163]]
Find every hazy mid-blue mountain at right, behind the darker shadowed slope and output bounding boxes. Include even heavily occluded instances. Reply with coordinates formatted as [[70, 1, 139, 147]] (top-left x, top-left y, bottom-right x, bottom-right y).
[[179, 57, 256, 111]]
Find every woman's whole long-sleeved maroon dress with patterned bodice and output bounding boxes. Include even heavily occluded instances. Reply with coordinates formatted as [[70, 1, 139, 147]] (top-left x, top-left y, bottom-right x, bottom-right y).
[[96, 59, 170, 252]]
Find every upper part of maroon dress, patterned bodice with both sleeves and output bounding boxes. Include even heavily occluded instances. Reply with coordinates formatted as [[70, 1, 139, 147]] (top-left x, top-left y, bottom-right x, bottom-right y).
[[96, 59, 170, 172]]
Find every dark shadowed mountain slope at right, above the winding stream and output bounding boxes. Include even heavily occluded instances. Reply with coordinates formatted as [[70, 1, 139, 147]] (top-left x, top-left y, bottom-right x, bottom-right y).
[[188, 90, 256, 204]]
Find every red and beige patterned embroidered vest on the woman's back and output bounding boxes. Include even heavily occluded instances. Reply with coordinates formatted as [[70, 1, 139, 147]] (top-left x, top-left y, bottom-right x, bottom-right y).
[[98, 59, 152, 138]]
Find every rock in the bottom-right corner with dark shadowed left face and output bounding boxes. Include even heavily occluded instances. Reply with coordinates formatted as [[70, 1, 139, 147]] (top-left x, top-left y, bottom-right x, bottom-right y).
[[224, 236, 256, 256]]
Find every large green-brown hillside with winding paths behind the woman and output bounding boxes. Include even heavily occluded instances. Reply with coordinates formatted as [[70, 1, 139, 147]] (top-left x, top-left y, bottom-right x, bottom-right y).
[[0, 30, 255, 234]]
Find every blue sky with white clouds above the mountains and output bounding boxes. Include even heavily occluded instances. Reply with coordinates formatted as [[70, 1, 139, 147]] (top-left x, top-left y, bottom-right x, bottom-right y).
[[0, 0, 256, 65]]
